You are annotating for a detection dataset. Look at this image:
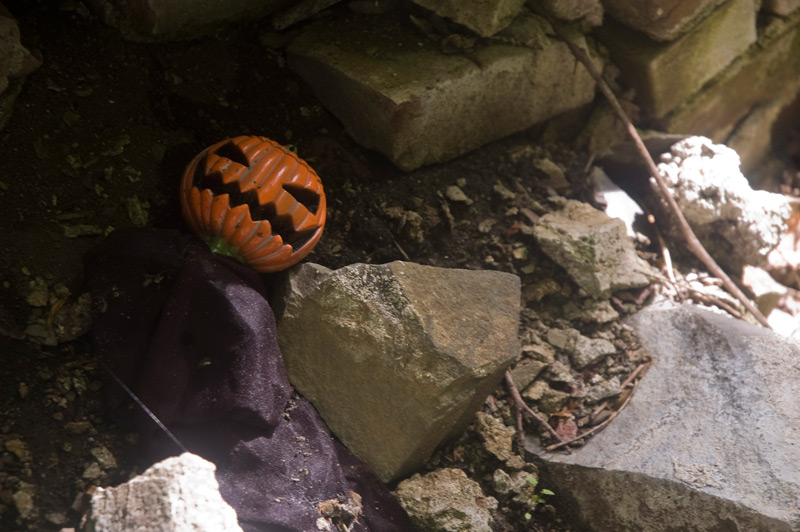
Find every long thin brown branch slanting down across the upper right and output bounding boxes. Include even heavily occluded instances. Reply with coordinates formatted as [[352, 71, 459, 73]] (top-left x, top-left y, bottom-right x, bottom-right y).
[[529, 2, 771, 329]]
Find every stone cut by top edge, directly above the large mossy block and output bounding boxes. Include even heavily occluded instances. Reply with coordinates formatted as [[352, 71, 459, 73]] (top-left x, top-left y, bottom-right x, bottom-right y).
[[413, 0, 525, 37]]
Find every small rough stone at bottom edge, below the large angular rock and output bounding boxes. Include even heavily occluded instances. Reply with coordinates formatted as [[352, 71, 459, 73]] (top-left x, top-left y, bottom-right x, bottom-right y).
[[394, 469, 497, 532]]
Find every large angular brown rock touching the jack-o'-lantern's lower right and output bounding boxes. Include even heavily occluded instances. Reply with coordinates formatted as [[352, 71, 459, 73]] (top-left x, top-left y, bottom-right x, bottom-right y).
[[278, 262, 520, 481]]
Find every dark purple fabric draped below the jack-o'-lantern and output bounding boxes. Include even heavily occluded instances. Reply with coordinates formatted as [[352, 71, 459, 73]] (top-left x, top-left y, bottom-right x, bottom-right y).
[[84, 229, 412, 532]]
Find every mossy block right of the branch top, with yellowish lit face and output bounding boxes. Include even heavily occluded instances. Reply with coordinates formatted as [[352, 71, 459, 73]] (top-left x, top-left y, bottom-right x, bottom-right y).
[[598, 0, 756, 117]]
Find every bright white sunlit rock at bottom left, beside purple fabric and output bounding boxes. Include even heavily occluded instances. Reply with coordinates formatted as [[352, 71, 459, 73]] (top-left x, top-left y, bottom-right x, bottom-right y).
[[83, 453, 242, 532]]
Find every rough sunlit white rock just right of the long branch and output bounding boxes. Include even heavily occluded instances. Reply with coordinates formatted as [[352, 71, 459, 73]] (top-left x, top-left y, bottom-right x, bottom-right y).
[[653, 137, 791, 272]]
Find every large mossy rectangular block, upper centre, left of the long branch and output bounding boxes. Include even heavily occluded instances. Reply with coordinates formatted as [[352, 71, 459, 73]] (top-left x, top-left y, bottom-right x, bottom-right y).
[[288, 15, 600, 170]]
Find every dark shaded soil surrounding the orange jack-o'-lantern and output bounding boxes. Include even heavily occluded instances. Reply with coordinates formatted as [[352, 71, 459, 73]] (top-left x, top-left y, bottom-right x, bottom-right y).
[[0, 2, 724, 531]]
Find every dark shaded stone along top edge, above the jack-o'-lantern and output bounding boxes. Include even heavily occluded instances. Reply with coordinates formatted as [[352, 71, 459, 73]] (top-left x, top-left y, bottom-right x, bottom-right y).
[[87, 0, 292, 41]]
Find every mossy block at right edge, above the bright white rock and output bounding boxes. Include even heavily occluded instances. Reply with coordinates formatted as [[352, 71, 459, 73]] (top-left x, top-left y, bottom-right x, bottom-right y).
[[661, 11, 800, 171]]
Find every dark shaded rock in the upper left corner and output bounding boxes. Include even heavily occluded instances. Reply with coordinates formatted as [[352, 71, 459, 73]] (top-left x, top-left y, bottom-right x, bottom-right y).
[[0, 4, 41, 129]]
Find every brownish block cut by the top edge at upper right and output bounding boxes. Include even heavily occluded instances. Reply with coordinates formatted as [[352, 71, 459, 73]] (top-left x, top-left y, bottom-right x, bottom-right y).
[[603, 0, 728, 41]]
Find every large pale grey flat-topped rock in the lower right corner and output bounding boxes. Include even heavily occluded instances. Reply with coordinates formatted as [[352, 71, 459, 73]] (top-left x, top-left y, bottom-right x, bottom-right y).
[[530, 305, 800, 532]]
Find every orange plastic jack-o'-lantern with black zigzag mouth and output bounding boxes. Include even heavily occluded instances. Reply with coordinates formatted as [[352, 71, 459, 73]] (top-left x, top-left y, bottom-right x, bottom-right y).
[[181, 136, 325, 272]]
